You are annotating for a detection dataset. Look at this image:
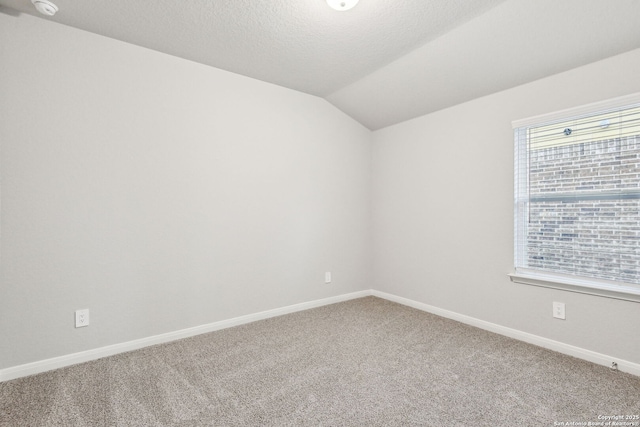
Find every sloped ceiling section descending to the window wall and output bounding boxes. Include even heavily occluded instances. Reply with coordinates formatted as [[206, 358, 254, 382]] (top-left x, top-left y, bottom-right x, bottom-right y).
[[327, 0, 640, 129]]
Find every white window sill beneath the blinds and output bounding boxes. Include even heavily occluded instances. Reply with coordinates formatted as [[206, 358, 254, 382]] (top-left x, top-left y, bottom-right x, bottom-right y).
[[508, 273, 640, 302]]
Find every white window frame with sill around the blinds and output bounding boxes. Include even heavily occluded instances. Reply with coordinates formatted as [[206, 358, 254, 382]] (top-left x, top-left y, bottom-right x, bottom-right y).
[[508, 92, 640, 302]]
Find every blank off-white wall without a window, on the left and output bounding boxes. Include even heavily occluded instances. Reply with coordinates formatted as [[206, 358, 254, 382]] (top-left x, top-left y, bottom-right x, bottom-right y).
[[0, 13, 371, 368]]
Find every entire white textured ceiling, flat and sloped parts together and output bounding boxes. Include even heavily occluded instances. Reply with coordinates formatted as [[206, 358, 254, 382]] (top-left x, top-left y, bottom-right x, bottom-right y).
[[0, 0, 640, 129]]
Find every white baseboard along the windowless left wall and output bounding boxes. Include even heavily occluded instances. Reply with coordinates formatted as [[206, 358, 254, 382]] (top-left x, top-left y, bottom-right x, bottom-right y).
[[0, 290, 371, 382]]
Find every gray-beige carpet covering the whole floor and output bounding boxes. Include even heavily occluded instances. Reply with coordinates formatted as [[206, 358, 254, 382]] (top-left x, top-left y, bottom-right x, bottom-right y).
[[0, 297, 640, 427]]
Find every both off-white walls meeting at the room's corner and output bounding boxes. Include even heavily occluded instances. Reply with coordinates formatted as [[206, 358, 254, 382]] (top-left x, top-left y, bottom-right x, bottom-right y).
[[0, 10, 640, 376]]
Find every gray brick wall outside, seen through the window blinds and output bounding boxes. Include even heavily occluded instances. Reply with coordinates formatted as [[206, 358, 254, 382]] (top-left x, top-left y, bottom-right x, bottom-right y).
[[527, 135, 640, 284]]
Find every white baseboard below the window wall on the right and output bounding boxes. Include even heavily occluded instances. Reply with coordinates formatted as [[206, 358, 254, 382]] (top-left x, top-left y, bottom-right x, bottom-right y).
[[371, 290, 640, 376]]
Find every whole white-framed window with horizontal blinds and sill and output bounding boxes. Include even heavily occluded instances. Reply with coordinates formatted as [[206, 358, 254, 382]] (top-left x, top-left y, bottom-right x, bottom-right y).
[[510, 94, 640, 301]]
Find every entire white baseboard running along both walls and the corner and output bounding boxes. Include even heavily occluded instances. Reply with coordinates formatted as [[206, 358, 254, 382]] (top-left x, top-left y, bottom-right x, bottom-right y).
[[0, 290, 640, 382]]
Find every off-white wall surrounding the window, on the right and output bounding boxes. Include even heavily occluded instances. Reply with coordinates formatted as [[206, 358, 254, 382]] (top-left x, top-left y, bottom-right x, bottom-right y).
[[373, 50, 640, 363]]
